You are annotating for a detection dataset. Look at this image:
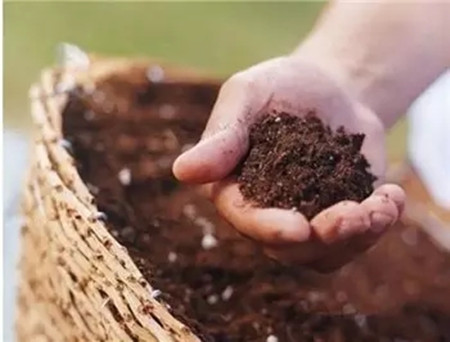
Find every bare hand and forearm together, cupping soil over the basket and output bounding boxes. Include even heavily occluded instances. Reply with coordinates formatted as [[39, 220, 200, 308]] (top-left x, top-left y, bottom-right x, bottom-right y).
[[173, 2, 450, 271]]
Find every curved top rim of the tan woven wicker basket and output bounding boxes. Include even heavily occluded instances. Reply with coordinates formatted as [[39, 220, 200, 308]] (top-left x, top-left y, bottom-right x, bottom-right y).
[[30, 57, 221, 342]]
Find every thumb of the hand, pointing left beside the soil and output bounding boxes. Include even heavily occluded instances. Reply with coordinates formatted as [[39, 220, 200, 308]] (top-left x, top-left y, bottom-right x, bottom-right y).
[[173, 74, 252, 183]]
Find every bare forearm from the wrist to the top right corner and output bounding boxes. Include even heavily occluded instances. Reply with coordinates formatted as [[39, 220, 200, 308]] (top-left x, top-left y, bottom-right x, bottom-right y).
[[294, 2, 450, 127]]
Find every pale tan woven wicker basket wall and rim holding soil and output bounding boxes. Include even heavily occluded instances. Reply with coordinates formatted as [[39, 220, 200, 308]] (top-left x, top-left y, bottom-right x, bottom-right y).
[[17, 54, 218, 342]]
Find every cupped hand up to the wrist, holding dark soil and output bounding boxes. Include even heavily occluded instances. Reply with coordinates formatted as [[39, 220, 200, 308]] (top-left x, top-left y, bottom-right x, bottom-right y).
[[173, 57, 405, 270]]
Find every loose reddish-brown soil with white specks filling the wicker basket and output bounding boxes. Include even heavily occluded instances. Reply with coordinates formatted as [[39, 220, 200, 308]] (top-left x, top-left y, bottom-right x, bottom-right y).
[[63, 69, 450, 342]]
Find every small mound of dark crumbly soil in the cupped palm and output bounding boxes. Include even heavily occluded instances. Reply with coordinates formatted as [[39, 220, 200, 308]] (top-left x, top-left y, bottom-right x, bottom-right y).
[[238, 113, 376, 219]]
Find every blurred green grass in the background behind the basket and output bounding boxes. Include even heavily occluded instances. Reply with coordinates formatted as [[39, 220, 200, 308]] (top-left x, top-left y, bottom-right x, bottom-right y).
[[4, 2, 404, 160]]
